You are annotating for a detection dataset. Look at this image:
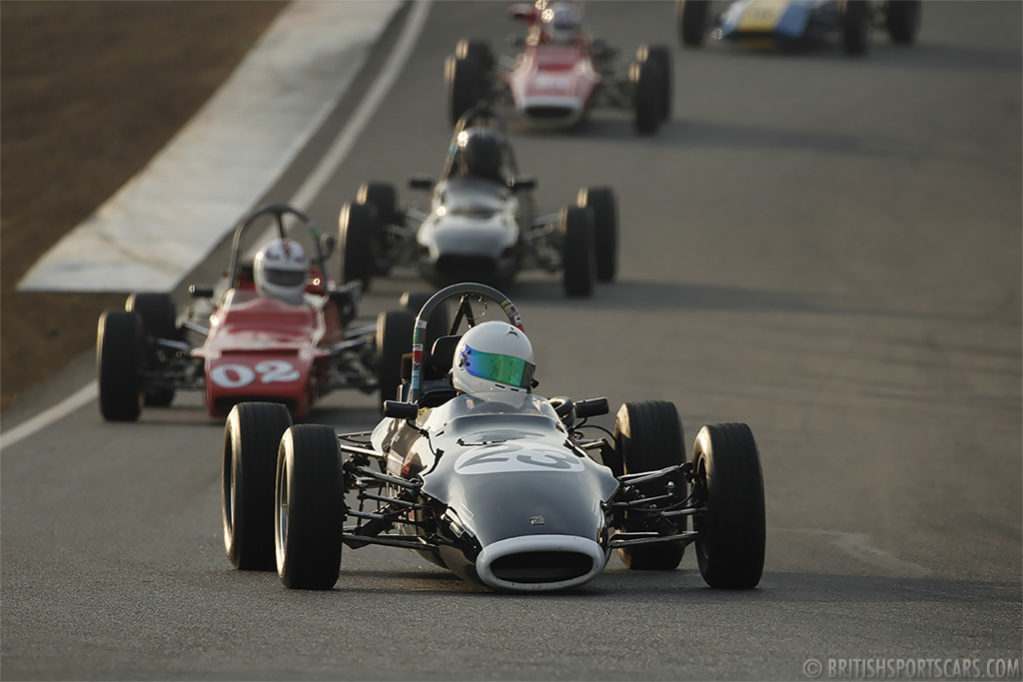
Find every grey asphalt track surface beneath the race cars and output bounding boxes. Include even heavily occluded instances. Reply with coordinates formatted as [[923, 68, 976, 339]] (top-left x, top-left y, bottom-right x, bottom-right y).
[[0, 2, 1021, 680]]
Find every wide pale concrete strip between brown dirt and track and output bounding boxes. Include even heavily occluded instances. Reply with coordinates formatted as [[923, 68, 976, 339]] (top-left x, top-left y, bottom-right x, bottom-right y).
[[18, 0, 402, 291]]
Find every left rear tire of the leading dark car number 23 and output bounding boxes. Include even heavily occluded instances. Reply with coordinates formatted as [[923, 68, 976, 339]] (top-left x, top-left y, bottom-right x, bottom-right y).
[[221, 403, 292, 571]]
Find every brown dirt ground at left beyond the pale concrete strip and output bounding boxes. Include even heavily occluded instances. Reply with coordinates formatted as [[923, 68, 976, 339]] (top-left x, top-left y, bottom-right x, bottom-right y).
[[0, 0, 287, 408]]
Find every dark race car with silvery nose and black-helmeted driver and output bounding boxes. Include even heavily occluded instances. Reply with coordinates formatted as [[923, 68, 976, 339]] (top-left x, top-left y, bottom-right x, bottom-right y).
[[339, 105, 618, 297]]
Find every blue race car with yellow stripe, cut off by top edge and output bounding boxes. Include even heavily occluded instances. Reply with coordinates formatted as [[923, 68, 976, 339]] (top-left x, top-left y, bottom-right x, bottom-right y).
[[675, 0, 921, 54]]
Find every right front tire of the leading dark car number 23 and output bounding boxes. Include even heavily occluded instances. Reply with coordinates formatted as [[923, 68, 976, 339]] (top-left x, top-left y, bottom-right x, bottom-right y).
[[693, 423, 766, 589]]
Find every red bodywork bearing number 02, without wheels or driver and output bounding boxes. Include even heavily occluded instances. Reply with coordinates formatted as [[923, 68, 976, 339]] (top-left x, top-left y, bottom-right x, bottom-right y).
[[192, 277, 344, 419]]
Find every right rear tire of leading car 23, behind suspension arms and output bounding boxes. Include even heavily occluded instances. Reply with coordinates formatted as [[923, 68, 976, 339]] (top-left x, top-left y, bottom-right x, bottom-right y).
[[614, 400, 686, 571]]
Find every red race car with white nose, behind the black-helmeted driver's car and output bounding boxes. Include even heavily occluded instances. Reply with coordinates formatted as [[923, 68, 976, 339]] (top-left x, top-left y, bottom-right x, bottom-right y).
[[444, 0, 672, 134]]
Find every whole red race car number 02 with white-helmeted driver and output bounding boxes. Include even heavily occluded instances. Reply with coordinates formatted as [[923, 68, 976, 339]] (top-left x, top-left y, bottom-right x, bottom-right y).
[[96, 204, 415, 421]]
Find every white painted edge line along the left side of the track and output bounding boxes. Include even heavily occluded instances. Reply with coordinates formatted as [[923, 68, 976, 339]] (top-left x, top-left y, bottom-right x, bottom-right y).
[[0, 0, 432, 449]]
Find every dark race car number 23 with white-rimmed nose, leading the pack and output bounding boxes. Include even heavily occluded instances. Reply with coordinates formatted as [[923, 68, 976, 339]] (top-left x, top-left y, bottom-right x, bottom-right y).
[[223, 283, 764, 592]]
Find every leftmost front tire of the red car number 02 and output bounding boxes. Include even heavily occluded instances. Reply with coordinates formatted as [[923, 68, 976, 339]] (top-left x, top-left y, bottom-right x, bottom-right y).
[[96, 310, 145, 421]]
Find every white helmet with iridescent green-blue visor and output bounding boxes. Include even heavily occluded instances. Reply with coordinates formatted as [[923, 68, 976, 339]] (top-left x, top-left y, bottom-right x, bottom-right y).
[[451, 321, 536, 405]]
